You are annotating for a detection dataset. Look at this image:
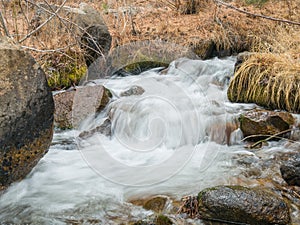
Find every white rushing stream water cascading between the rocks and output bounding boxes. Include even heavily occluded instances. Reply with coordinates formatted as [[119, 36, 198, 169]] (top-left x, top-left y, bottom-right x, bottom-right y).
[[0, 57, 300, 224]]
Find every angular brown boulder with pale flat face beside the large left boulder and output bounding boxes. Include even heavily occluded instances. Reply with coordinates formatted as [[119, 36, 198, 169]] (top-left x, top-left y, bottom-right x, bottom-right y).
[[54, 85, 111, 129]]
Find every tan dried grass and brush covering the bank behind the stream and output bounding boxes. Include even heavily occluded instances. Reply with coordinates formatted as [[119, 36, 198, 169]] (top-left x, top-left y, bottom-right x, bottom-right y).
[[0, 0, 300, 92]]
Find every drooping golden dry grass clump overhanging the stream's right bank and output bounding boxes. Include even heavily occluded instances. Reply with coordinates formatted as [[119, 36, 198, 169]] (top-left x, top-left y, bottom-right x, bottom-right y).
[[228, 50, 300, 113]]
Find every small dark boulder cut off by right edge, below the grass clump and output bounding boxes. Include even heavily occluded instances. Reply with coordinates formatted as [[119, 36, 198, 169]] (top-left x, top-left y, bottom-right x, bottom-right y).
[[280, 154, 300, 186]]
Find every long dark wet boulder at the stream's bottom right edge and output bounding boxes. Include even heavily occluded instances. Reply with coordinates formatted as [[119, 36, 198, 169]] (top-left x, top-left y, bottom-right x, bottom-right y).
[[198, 186, 290, 225]]
